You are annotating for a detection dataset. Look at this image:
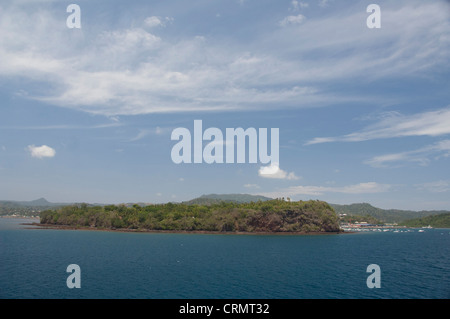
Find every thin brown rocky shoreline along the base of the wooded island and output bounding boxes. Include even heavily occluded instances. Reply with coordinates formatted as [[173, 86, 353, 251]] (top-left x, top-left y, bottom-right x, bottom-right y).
[[26, 223, 346, 236]]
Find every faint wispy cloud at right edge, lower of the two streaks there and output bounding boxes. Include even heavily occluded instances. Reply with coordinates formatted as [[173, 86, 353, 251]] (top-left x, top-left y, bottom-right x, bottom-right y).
[[365, 140, 450, 167]]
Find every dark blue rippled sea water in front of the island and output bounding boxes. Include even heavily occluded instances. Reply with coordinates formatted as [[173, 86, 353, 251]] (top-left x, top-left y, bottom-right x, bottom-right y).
[[0, 218, 450, 299]]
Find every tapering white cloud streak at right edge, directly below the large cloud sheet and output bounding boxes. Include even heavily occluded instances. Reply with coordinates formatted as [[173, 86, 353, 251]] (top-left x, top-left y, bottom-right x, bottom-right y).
[[306, 107, 450, 145]]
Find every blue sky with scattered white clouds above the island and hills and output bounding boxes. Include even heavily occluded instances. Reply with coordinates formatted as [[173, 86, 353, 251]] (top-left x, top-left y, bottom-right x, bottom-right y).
[[0, 0, 450, 210]]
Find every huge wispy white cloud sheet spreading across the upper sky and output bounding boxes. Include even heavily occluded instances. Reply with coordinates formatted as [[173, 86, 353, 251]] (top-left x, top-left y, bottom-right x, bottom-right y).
[[0, 1, 450, 116]]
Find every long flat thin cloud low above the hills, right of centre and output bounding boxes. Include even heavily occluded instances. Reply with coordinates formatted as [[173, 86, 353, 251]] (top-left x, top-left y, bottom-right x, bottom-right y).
[[262, 182, 391, 198]]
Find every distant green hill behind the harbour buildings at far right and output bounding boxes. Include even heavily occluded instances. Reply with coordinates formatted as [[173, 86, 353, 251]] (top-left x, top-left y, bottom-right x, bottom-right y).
[[330, 203, 450, 223]]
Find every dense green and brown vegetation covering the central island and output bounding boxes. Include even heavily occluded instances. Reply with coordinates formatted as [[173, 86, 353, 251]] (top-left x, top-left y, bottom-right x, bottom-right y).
[[41, 199, 339, 232]]
